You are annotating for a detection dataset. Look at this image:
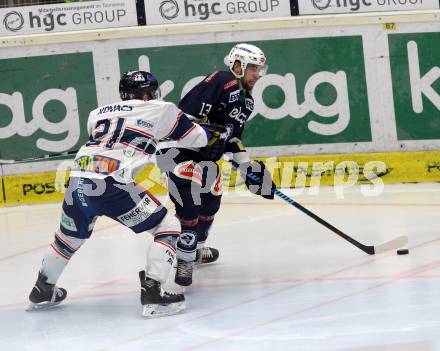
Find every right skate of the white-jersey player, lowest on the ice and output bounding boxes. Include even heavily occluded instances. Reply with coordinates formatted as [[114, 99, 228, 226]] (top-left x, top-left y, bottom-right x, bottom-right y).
[[139, 271, 185, 318]]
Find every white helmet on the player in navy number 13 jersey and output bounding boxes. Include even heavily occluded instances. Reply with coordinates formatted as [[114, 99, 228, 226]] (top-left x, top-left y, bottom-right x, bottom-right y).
[[226, 43, 267, 78]]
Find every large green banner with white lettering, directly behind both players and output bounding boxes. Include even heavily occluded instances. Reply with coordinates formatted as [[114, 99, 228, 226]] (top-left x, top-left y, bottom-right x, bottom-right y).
[[119, 36, 371, 146]]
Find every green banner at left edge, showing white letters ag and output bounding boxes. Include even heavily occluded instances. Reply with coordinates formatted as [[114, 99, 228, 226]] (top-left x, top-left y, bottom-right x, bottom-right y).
[[0, 52, 97, 159]]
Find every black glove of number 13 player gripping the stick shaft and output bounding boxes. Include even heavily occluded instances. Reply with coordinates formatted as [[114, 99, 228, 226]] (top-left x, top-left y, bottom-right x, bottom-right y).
[[240, 161, 276, 200]]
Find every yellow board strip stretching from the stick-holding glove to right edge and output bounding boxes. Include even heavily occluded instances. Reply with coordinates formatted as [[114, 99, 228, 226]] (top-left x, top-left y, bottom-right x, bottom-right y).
[[278, 151, 440, 187]]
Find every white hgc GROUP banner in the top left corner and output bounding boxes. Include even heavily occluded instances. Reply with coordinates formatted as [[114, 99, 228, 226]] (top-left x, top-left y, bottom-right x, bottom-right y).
[[0, 0, 138, 37]]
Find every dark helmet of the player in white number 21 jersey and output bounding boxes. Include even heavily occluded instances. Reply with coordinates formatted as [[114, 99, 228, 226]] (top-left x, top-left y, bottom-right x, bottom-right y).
[[119, 71, 160, 100]]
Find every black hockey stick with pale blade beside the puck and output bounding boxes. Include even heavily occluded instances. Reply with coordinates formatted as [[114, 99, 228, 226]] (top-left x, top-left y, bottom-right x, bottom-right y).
[[237, 162, 408, 255]]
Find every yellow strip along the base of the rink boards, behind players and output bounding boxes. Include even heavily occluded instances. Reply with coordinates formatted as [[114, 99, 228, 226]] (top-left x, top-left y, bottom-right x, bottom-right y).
[[0, 151, 440, 205]]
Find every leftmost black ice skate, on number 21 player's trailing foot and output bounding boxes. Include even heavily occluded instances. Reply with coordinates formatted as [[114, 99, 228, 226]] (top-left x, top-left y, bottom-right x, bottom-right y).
[[26, 272, 67, 311]]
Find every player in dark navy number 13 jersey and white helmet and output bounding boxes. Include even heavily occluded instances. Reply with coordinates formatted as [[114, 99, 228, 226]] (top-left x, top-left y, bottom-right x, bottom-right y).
[[158, 44, 274, 286]]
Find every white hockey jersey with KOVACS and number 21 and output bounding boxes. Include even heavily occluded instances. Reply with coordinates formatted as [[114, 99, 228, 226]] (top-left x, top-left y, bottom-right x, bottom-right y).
[[71, 100, 208, 183]]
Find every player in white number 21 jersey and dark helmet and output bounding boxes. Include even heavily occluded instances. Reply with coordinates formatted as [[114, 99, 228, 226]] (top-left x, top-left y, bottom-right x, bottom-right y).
[[28, 71, 225, 317]]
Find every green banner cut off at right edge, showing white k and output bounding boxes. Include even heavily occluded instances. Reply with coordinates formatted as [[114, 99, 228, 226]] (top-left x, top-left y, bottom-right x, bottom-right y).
[[388, 32, 440, 140]]
